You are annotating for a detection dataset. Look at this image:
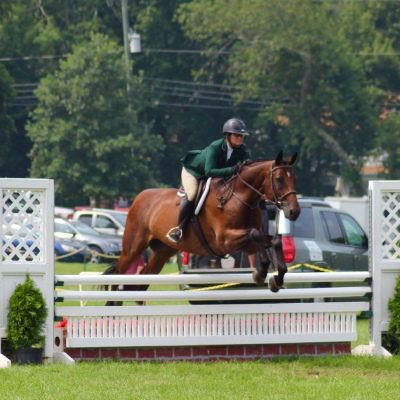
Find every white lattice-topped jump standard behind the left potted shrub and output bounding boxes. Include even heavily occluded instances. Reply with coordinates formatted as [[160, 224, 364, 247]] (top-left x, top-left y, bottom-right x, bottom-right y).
[[0, 178, 54, 366]]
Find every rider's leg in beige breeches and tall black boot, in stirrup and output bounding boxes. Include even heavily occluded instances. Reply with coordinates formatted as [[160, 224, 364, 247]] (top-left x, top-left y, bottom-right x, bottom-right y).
[[166, 168, 198, 243]]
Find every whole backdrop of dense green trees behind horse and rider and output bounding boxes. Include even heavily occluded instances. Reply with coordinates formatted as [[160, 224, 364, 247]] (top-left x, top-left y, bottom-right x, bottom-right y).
[[0, 0, 400, 195]]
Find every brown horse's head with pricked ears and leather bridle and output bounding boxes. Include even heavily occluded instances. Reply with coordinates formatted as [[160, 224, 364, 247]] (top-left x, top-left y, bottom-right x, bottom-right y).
[[264, 151, 300, 221]]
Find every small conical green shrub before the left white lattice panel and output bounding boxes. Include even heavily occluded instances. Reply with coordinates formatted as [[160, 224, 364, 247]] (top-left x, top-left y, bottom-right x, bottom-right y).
[[7, 274, 48, 350]]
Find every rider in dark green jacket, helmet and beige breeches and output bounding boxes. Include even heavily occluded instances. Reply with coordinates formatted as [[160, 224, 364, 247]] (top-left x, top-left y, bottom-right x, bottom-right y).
[[167, 118, 250, 243]]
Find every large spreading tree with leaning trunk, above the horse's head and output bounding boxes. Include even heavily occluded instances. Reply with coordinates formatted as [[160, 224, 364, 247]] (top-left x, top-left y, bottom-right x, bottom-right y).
[[178, 0, 391, 195]]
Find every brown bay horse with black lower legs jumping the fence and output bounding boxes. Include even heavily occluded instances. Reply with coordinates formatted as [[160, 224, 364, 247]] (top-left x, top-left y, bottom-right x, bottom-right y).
[[111, 152, 300, 292]]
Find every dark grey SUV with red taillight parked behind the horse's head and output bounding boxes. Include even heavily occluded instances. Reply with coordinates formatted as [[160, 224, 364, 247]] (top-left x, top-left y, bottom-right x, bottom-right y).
[[183, 198, 368, 271]]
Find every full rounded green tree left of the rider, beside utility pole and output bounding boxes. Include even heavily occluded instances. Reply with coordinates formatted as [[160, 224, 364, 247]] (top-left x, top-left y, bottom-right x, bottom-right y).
[[27, 34, 163, 204]]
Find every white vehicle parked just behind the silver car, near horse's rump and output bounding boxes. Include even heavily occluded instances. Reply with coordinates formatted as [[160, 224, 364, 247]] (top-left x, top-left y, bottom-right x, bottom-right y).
[[72, 208, 128, 236]]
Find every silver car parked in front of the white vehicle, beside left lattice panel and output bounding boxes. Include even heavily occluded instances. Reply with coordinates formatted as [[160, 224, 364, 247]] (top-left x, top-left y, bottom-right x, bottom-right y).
[[54, 218, 121, 263]]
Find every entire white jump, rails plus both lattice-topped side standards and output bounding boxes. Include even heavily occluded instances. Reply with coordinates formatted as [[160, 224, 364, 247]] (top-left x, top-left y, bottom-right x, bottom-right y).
[[0, 179, 400, 366]]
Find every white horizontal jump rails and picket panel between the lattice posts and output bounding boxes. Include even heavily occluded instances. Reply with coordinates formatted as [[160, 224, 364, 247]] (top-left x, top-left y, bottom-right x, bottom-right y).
[[55, 272, 371, 354]]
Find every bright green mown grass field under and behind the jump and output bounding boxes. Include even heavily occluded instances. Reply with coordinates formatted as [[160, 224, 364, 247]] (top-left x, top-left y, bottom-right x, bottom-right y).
[[0, 263, 400, 400]]
